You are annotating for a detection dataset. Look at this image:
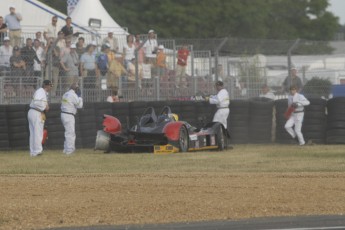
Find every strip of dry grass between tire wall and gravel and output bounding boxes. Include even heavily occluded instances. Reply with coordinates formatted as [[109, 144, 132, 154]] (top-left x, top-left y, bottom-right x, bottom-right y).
[[0, 145, 345, 174]]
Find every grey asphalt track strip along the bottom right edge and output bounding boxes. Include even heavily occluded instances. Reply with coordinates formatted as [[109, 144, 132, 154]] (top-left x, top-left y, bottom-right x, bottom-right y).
[[49, 216, 345, 230]]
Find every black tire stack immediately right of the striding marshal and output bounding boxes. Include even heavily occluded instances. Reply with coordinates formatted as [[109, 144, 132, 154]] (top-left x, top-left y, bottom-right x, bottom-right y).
[[302, 98, 327, 144]]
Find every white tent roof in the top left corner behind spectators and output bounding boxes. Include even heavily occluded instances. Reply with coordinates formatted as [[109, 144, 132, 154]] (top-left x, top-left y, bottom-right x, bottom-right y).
[[0, 0, 67, 33]]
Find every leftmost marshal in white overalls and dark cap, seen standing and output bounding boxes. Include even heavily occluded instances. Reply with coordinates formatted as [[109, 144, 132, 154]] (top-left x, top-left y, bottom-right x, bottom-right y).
[[28, 80, 53, 157]]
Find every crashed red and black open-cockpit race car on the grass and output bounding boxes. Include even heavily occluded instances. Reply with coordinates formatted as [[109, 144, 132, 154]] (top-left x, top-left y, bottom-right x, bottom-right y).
[[95, 106, 229, 154]]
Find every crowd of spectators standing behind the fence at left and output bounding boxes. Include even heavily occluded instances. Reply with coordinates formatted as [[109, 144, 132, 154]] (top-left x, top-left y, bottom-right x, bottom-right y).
[[0, 6, 189, 99]]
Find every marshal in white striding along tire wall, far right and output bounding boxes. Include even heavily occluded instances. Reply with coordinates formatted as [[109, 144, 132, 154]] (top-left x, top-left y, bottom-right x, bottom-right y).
[[285, 85, 310, 145]]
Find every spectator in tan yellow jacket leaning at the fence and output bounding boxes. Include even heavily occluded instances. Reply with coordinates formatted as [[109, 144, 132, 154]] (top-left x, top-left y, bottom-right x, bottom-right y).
[[107, 57, 128, 88]]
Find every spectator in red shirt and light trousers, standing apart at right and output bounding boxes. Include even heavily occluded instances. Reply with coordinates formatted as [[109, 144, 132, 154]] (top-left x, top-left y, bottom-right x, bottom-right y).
[[175, 45, 189, 88]]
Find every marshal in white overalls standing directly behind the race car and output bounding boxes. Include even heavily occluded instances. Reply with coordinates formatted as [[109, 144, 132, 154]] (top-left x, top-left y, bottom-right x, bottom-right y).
[[209, 81, 230, 129]]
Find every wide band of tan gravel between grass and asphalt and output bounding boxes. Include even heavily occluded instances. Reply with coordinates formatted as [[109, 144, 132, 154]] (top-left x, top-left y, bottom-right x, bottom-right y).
[[0, 173, 345, 229]]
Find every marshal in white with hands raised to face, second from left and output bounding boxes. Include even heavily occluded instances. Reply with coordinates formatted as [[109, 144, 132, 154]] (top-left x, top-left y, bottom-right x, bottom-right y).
[[61, 83, 83, 155]]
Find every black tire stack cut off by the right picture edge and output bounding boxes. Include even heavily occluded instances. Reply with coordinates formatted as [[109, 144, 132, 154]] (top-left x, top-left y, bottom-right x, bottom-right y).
[[326, 97, 345, 144]]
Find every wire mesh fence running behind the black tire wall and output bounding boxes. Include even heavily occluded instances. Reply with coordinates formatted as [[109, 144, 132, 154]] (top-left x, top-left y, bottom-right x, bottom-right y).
[[0, 33, 345, 104]]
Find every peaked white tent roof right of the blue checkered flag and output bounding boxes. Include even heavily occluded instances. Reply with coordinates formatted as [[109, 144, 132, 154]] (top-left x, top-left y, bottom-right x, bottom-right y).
[[70, 0, 127, 35]]
